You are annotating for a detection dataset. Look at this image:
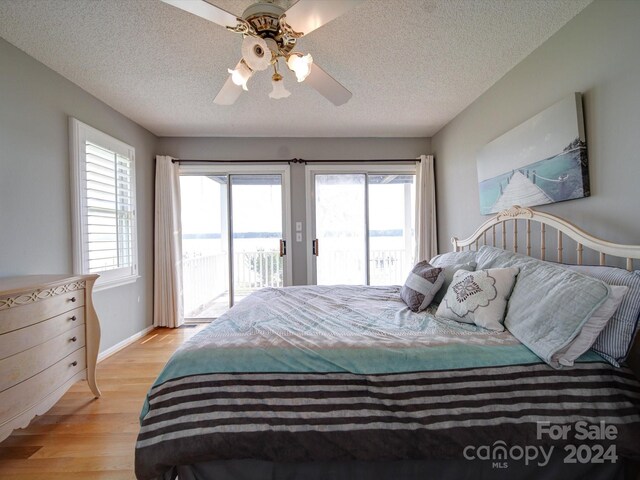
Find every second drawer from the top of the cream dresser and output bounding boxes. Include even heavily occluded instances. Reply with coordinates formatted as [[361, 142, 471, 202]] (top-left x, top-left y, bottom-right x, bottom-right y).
[[0, 307, 84, 360]]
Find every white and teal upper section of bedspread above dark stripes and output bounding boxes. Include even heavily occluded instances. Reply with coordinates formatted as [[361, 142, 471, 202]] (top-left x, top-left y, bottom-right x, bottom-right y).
[[143, 285, 584, 394]]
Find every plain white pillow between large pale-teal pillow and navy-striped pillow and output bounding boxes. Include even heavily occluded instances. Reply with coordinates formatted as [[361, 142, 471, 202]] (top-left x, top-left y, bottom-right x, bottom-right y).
[[551, 285, 629, 367]]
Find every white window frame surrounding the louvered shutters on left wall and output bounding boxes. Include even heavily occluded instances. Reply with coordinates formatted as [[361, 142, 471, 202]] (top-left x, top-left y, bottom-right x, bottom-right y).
[[69, 117, 139, 291]]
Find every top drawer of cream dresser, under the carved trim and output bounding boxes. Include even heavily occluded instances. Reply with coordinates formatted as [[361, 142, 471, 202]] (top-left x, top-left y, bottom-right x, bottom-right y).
[[0, 289, 85, 334]]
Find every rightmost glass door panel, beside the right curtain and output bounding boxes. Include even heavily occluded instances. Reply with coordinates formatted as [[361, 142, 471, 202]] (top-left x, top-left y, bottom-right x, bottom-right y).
[[367, 175, 415, 285]]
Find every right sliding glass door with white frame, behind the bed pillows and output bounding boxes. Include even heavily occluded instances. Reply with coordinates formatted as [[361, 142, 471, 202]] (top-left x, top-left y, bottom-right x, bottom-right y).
[[307, 165, 416, 285]]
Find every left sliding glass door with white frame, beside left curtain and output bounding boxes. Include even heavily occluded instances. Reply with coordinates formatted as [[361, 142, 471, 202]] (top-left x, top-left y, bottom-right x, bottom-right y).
[[180, 165, 291, 321]]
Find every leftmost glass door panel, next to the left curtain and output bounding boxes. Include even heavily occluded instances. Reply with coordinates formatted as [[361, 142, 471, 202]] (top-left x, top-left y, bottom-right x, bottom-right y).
[[180, 175, 229, 321]]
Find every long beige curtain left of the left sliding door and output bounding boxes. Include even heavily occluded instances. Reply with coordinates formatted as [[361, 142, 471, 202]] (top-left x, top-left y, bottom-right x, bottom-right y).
[[153, 155, 184, 328]]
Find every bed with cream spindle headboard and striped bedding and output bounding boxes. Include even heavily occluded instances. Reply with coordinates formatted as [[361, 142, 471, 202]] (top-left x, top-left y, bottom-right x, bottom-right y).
[[136, 207, 640, 480]]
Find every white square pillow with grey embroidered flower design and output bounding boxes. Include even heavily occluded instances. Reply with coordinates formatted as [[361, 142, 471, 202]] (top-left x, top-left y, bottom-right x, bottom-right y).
[[436, 267, 520, 332]]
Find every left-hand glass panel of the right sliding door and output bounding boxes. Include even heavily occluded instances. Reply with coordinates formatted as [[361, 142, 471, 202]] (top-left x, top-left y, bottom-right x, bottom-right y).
[[314, 174, 367, 285]]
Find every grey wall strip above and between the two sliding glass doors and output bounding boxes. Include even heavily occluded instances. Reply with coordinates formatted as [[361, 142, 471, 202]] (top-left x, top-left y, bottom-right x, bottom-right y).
[[158, 137, 431, 285]]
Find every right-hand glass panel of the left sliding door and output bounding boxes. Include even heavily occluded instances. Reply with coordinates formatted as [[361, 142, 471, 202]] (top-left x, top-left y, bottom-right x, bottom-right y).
[[231, 174, 285, 304]]
